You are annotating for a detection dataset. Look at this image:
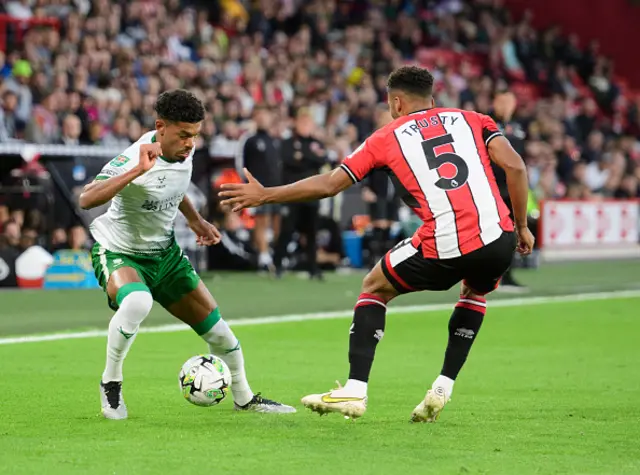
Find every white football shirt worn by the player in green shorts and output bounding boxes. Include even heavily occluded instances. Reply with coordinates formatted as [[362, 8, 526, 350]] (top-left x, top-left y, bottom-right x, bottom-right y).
[[90, 131, 193, 255]]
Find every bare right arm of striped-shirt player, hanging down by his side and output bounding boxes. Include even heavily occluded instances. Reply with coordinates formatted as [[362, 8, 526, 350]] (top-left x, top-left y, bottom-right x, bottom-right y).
[[488, 136, 534, 254]]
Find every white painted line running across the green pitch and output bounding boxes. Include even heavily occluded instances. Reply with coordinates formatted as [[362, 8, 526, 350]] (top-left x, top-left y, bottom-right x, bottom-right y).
[[0, 290, 640, 345]]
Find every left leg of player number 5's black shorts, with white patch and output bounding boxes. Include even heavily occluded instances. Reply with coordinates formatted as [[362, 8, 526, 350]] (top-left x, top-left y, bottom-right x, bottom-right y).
[[380, 238, 462, 294]]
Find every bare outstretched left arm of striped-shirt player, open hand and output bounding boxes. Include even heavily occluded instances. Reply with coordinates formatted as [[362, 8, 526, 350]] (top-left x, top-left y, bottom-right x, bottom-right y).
[[220, 168, 353, 211]]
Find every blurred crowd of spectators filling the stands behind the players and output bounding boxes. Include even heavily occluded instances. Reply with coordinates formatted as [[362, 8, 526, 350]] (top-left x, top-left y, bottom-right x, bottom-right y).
[[0, 0, 640, 276]]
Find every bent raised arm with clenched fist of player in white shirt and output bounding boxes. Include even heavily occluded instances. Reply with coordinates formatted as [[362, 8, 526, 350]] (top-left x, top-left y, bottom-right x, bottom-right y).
[[79, 142, 162, 209]]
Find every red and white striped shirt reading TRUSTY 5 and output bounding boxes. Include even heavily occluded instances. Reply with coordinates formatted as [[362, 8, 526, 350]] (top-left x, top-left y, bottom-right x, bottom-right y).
[[342, 108, 514, 259]]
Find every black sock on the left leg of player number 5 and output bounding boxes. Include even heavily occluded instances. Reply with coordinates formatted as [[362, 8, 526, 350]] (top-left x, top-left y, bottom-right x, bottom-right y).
[[349, 294, 387, 383]]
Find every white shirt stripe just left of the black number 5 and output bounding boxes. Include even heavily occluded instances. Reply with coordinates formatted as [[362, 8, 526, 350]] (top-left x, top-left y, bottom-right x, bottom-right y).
[[394, 120, 460, 259]]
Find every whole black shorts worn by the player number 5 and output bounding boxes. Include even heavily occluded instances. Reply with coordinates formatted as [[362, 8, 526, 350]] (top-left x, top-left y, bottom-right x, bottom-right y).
[[382, 232, 516, 295]]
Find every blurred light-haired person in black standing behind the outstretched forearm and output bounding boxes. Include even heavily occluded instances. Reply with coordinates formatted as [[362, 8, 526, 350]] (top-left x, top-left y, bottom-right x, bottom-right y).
[[274, 108, 328, 279]]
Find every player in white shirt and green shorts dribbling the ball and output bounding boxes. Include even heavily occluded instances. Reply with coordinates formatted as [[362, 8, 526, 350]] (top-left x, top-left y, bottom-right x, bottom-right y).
[[80, 89, 295, 419]]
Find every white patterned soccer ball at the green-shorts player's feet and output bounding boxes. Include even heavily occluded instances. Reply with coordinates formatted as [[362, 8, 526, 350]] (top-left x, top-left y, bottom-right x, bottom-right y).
[[178, 355, 231, 406]]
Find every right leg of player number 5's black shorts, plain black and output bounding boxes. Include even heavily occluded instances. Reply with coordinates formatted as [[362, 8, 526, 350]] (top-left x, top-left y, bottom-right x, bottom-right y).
[[462, 232, 517, 295]]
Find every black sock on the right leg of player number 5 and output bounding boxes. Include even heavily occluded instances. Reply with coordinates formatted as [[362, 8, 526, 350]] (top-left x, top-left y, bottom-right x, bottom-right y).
[[440, 296, 487, 380]]
